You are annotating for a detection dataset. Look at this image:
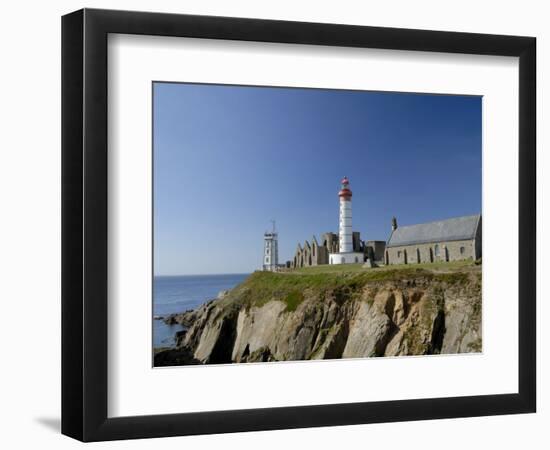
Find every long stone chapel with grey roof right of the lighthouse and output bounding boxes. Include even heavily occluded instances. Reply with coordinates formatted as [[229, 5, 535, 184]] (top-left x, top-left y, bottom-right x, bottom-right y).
[[385, 214, 481, 264]]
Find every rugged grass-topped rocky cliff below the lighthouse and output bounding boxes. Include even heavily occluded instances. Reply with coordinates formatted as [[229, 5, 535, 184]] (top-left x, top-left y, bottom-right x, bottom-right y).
[[156, 266, 481, 364]]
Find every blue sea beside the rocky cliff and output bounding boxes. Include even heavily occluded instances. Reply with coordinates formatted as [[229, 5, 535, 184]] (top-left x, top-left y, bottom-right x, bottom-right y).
[[153, 273, 250, 347]]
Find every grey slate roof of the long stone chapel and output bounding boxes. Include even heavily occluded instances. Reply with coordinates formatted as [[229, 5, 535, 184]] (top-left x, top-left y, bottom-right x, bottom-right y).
[[387, 214, 481, 247]]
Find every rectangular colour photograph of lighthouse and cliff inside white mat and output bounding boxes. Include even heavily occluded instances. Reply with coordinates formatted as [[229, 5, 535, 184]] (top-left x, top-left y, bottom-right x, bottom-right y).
[[151, 81, 483, 367]]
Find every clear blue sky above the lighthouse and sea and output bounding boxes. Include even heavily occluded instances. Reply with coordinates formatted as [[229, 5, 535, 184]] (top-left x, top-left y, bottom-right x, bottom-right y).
[[153, 83, 481, 275]]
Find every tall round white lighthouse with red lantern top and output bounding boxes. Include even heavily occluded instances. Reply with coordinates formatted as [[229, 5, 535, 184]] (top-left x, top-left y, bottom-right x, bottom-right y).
[[329, 177, 364, 264]]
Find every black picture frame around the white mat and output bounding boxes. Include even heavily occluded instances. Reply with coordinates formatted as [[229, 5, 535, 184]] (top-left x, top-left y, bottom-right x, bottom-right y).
[[62, 9, 536, 441]]
